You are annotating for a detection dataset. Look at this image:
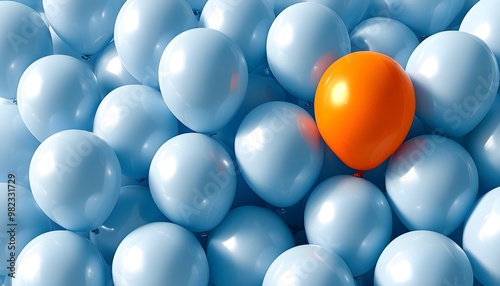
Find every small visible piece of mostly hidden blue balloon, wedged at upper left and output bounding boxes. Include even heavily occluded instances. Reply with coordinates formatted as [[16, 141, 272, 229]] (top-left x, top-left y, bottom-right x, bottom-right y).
[[94, 42, 139, 95]]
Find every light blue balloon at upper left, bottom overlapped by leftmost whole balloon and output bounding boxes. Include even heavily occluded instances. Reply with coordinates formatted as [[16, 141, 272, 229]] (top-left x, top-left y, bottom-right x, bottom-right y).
[[17, 55, 101, 142]]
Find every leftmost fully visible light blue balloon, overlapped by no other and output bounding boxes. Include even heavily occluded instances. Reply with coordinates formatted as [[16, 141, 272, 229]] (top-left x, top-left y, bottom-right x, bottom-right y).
[[29, 130, 121, 231]]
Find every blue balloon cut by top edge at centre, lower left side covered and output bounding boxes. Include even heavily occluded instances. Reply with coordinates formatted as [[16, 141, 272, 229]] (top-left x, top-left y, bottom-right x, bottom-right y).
[[200, 0, 275, 71]]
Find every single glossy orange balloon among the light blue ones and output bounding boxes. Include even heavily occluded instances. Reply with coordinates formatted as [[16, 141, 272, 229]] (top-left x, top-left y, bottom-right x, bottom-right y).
[[314, 52, 415, 170]]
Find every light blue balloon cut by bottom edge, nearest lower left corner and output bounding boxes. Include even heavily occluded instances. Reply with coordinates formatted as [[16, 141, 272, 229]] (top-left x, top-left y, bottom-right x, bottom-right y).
[[14, 230, 106, 286]]
